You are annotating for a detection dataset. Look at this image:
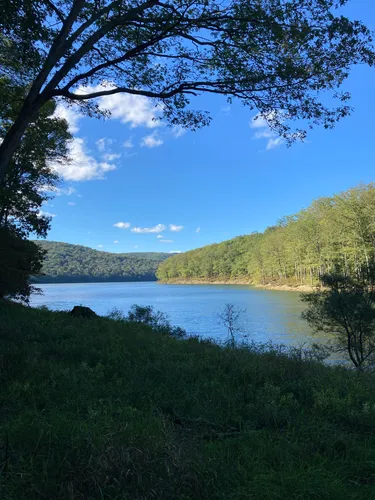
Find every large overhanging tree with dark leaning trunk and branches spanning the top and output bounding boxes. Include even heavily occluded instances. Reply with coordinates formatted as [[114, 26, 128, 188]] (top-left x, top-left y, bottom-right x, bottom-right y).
[[0, 0, 374, 182]]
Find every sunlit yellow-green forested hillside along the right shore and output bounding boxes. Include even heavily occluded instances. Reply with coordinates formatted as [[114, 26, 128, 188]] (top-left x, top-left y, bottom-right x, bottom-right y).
[[157, 184, 375, 284]]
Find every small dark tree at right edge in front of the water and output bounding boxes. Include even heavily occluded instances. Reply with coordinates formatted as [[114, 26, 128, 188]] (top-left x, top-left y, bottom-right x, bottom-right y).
[[301, 273, 375, 370]]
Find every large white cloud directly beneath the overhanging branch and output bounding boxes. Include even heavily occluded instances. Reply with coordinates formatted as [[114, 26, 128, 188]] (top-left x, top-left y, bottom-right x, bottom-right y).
[[78, 84, 162, 128]]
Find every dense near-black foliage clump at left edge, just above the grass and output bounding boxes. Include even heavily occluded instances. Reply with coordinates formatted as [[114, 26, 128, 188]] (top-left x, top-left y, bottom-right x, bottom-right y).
[[0, 227, 44, 302]]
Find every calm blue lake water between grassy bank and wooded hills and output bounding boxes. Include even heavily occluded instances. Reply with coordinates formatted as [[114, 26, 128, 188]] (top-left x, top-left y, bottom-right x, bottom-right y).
[[31, 283, 318, 345]]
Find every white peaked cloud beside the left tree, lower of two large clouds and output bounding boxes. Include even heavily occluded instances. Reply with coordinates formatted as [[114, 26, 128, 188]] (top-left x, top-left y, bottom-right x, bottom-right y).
[[51, 137, 116, 181]]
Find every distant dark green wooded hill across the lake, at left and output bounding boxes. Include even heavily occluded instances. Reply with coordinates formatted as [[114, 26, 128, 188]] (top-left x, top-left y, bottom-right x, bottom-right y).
[[35, 241, 170, 283]]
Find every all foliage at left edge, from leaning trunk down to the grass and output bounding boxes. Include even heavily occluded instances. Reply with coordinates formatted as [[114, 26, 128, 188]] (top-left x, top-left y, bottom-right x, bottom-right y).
[[0, 79, 71, 301]]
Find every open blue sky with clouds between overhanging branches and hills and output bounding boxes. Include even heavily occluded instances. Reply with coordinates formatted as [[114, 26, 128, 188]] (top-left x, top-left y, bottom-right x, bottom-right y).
[[43, 0, 375, 252]]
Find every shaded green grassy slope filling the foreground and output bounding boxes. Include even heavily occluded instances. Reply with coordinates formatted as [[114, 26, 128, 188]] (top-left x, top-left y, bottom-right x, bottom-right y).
[[0, 303, 375, 500]]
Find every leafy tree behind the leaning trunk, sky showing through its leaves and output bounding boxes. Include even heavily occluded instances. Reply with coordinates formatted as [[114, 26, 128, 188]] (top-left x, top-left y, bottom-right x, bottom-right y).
[[0, 78, 71, 237]]
